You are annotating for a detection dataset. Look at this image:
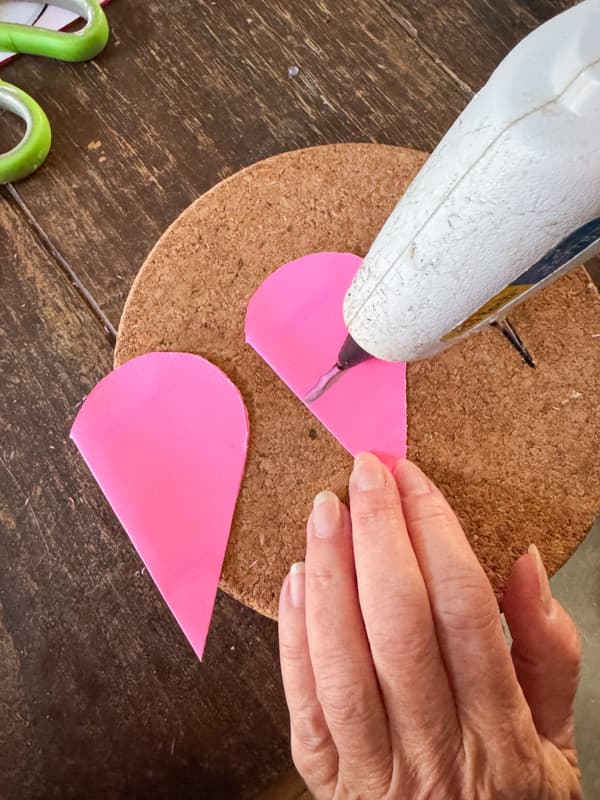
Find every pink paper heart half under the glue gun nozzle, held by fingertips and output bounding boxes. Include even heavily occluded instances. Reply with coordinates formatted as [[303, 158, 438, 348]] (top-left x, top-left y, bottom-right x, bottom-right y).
[[246, 253, 407, 466]]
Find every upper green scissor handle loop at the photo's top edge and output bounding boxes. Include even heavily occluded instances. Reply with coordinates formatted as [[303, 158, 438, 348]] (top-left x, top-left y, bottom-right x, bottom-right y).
[[0, 0, 108, 61]]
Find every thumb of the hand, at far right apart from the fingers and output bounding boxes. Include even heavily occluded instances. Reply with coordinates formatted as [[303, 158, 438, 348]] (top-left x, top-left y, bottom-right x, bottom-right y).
[[504, 544, 581, 750]]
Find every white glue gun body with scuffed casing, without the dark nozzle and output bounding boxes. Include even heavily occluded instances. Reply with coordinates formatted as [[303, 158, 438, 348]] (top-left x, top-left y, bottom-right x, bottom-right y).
[[344, 0, 600, 361]]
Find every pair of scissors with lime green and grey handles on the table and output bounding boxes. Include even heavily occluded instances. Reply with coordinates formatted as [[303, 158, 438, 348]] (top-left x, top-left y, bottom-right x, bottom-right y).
[[0, 0, 108, 183]]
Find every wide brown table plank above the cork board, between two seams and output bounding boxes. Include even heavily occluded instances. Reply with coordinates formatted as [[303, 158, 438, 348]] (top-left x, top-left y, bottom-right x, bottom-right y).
[[3, 0, 466, 326]]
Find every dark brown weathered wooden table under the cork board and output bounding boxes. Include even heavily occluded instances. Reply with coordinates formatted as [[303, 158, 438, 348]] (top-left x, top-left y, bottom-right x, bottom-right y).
[[0, 0, 571, 800]]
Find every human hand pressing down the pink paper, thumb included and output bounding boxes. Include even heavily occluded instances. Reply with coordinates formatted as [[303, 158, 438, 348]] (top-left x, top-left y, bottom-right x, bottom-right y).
[[279, 454, 581, 800]]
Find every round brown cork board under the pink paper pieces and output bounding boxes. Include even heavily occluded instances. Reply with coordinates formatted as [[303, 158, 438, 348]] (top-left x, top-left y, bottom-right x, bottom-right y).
[[115, 144, 600, 617]]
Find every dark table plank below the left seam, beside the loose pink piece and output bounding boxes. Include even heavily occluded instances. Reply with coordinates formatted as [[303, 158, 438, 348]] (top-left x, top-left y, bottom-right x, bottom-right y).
[[0, 197, 288, 800]]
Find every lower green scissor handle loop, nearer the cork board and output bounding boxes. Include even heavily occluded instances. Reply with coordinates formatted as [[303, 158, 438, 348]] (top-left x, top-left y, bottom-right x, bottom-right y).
[[0, 81, 52, 183]]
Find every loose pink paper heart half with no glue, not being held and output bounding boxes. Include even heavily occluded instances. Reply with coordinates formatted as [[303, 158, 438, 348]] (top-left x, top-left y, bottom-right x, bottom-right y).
[[71, 353, 248, 659]]
